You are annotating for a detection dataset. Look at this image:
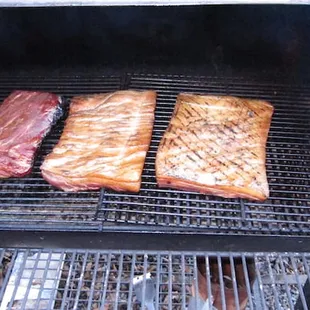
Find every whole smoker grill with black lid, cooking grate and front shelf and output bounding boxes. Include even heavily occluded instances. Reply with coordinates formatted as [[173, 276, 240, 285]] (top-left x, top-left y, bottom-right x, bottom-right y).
[[0, 0, 310, 310]]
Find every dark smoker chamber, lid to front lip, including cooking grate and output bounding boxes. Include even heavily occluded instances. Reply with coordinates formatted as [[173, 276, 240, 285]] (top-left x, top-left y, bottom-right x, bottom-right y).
[[0, 5, 310, 251]]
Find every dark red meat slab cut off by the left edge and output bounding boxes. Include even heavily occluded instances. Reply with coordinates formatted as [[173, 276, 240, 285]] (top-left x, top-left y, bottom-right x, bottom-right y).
[[0, 91, 62, 178]]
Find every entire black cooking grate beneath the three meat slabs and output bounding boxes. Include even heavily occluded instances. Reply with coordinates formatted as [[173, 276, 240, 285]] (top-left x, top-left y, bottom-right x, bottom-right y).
[[0, 75, 310, 236]]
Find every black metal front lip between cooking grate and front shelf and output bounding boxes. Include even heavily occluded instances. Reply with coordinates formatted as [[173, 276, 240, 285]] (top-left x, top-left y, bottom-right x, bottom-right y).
[[0, 231, 310, 252]]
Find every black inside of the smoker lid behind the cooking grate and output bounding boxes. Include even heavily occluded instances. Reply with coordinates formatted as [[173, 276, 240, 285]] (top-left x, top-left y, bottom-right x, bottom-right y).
[[0, 5, 310, 76]]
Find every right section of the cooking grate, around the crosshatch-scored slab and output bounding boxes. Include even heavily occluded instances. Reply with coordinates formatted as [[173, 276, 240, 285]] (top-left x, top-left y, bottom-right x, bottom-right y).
[[99, 76, 310, 234]]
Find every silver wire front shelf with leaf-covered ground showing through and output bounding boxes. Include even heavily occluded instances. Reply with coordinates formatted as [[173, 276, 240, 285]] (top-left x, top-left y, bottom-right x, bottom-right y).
[[0, 249, 310, 310]]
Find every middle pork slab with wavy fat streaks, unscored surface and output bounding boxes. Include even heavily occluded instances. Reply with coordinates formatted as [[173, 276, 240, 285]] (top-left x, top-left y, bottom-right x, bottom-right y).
[[41, 90, 156, 192]]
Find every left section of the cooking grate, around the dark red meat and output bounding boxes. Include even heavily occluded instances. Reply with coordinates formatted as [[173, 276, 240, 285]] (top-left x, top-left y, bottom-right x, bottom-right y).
[[0, 76, 121, 230]]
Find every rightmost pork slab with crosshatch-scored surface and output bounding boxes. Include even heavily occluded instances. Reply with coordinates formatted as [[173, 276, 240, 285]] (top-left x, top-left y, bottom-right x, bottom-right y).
[[156, 93, 273, 200]]
